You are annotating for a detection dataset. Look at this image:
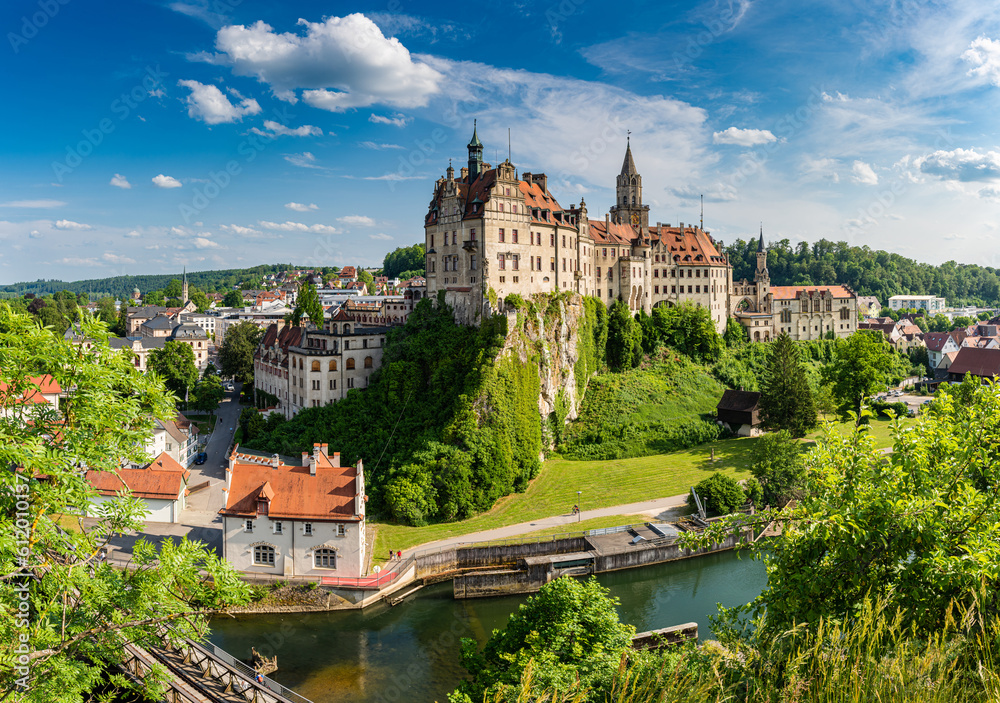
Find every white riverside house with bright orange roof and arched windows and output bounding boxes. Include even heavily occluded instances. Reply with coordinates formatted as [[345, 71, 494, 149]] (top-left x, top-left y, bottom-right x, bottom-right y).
[[219, 444, 367, 577]]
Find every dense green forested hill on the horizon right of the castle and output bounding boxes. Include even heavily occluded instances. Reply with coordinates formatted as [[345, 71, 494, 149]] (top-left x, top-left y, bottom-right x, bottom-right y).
[[724, 239, 1000, 305]]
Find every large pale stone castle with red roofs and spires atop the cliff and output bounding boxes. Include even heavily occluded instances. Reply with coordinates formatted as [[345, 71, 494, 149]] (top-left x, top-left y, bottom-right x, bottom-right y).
[[424, 128, 857, 341]]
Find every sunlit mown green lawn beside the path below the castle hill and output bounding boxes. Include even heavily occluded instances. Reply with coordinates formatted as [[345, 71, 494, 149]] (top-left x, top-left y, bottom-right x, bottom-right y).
[[372, 418, 916, 563]]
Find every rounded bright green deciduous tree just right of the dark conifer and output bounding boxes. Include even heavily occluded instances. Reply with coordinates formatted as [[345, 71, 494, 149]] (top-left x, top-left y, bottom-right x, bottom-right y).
[[823, 330, 896, 424]]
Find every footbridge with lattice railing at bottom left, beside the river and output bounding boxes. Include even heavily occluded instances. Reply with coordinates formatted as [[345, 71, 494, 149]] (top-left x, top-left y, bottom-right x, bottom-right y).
[[122, 639, 311, 703]]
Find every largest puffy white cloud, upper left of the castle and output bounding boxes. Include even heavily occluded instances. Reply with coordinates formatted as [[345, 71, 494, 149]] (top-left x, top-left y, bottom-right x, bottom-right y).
[[204, 14, 442, 112]]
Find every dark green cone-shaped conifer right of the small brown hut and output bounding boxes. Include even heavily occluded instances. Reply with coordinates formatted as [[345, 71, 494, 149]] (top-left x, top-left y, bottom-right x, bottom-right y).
[[760, 333, 816, 437]]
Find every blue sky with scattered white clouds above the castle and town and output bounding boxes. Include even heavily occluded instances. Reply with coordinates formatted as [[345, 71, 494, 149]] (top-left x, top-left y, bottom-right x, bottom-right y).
[[0, 0, 1000, 283]]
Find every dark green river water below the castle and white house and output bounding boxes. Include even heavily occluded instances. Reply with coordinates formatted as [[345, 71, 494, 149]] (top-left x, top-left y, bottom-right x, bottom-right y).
[[210, 552, 767, 703]]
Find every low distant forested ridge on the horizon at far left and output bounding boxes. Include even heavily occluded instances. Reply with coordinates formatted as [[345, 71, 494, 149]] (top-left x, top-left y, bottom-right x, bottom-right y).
[[0, 264, 304, 299]]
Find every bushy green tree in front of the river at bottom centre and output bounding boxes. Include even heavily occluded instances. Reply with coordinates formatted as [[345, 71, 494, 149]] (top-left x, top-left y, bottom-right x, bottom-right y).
[[450, 577, 635, 703]]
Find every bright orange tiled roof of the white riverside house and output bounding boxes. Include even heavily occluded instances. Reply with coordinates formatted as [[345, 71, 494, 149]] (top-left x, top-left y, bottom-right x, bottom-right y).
[[219, 451, 360, 520]]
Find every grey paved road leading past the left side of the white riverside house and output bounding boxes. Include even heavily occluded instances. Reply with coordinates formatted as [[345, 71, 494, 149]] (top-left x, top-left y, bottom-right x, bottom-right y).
[[181, 384, 242, 525]]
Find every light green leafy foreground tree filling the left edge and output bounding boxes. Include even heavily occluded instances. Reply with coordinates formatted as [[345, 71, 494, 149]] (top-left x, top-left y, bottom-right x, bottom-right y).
[[0, 303, 249, 703]]
